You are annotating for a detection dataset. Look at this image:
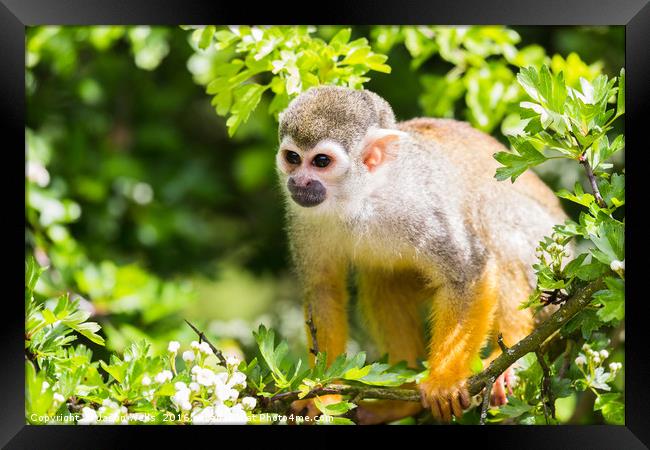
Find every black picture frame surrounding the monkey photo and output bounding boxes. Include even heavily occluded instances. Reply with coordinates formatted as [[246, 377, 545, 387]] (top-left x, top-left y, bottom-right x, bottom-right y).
[[0, 0, 650, 449]]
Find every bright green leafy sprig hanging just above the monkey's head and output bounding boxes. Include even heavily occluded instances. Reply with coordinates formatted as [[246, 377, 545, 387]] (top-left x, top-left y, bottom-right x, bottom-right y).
[[184, 25, 391, 136]]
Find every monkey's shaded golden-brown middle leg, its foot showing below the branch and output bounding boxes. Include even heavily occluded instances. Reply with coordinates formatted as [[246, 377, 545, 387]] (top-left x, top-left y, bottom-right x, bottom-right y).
[[355, 269, 431, 425]]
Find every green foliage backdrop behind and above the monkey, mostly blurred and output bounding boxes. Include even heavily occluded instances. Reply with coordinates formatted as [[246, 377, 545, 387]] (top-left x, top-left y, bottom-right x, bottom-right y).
[[25, 26, 624, 423]]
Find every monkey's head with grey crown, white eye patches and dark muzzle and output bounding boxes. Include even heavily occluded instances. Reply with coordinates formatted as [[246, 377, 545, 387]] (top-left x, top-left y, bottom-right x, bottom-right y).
[[276, 86, 403, 208]]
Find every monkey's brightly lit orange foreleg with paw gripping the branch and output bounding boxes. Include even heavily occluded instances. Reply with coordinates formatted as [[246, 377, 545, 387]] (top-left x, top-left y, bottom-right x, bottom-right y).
[[420, 262, 499, 422]]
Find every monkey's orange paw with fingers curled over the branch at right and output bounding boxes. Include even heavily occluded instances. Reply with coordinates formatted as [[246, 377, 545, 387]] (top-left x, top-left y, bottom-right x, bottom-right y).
[[419, 376, 470, 422]]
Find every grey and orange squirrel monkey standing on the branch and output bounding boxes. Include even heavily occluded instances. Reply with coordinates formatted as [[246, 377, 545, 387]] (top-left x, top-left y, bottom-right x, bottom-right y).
[[276, 86, 566, 421]]
